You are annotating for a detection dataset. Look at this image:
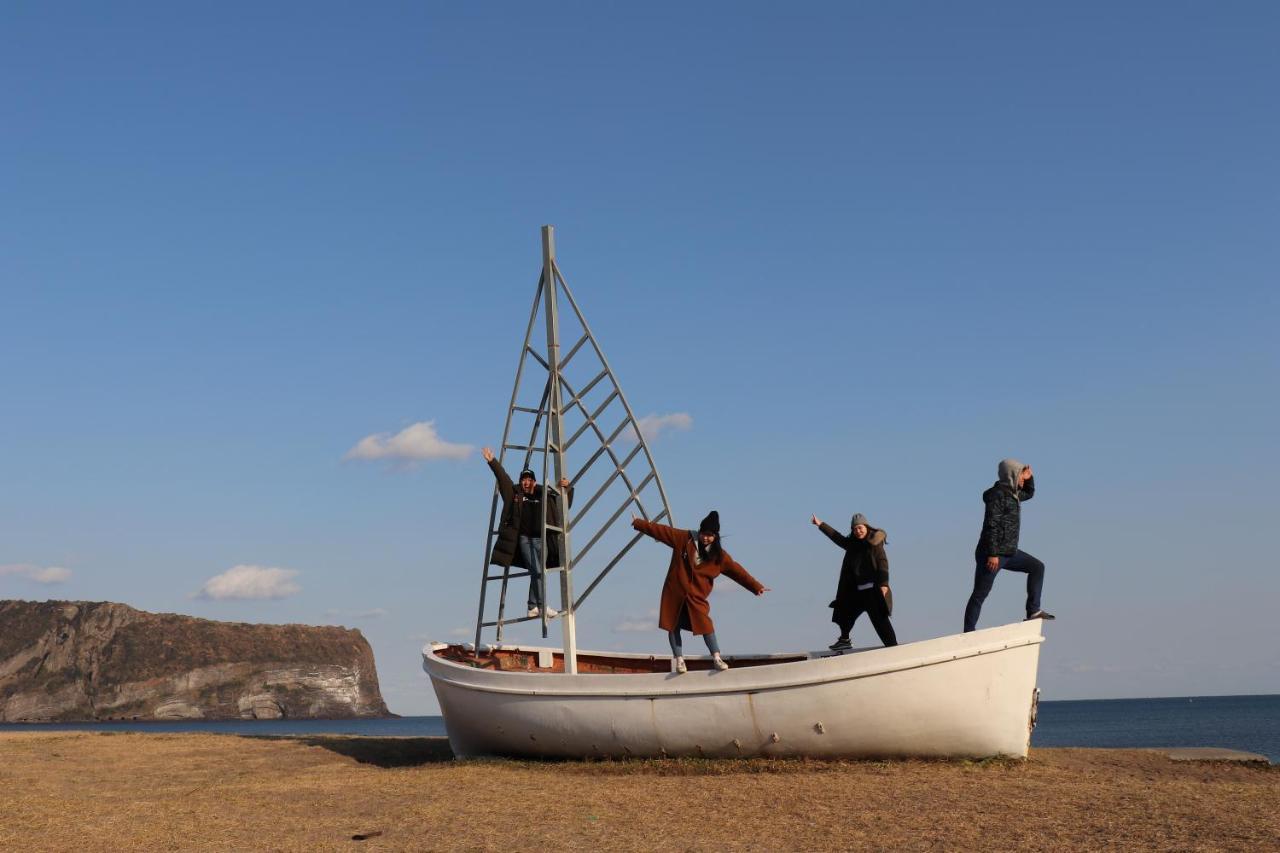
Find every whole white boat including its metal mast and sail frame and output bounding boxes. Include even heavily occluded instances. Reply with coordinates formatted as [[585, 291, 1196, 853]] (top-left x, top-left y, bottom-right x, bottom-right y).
[[422, 227, 1044, 758]]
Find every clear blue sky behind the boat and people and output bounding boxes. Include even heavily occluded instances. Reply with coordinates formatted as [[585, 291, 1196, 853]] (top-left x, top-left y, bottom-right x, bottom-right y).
[[0, 3, 1280, 713]]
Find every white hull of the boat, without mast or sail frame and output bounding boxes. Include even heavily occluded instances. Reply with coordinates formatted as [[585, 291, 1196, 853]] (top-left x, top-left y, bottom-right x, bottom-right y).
[[422, 620, 1043, 758]]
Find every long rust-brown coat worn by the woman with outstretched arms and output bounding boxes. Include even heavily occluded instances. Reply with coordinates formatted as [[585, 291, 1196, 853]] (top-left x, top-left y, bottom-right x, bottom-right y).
[[631, 519, 764, 634]]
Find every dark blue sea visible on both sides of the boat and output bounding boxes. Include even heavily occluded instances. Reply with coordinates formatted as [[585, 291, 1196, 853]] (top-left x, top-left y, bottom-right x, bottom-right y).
[[0, 695, 1280, 763]]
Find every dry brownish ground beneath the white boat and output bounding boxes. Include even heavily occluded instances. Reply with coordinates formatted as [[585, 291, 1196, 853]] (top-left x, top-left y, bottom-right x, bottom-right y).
[[0, 733, 1280, 850]]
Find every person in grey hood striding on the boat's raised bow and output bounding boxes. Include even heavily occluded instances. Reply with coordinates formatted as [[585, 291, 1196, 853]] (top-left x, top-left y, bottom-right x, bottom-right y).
[[964, 459, 1053, 633]]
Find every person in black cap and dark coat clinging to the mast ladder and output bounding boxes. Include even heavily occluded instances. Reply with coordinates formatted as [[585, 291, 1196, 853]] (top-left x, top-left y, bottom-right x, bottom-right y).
[[480, 447, 573, 619]]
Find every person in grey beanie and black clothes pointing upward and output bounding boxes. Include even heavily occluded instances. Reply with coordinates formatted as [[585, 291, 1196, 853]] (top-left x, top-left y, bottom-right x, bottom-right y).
[[810, 512, 897, 652]]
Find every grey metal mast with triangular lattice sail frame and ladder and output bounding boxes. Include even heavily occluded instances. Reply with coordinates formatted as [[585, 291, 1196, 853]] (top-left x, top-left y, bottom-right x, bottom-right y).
[[476, 225, 675, 672]]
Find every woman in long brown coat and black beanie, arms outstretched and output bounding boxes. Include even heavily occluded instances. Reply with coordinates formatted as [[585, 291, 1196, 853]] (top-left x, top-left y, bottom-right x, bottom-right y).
[[631, 510, 769, 672]]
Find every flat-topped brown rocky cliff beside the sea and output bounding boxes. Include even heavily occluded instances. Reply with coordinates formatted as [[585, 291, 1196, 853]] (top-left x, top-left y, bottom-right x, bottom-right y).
[[0, 601, 389, 722]]
